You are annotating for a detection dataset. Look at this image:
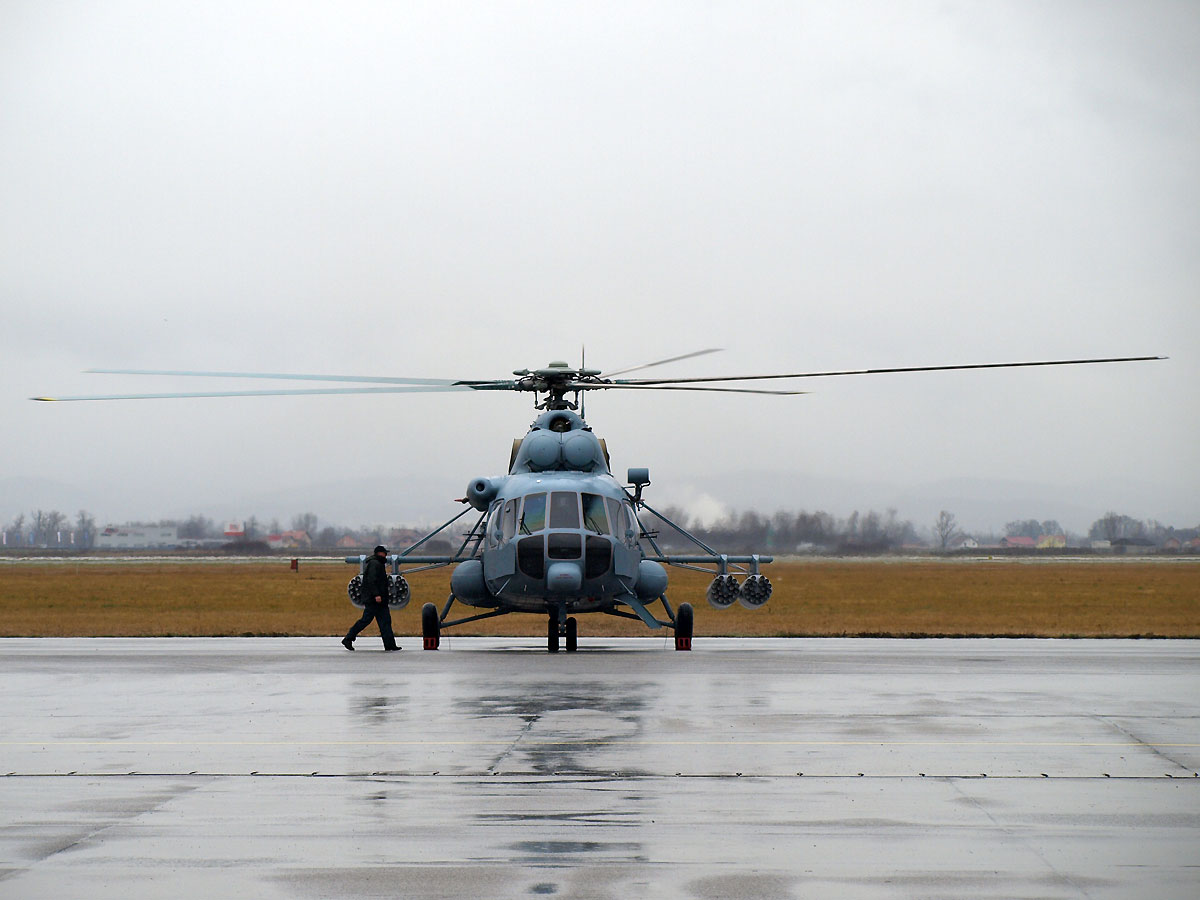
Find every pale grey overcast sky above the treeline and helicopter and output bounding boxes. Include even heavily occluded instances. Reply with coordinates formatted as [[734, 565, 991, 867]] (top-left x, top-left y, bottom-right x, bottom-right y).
[[0, 0, 1200, 527]]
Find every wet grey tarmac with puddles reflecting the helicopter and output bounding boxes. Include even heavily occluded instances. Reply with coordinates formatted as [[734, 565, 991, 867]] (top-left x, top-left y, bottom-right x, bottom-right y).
[[0, 636, 1200, 900]]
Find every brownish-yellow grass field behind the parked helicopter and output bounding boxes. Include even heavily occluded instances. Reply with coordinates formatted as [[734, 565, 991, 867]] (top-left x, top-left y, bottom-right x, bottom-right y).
[[0, 560, 1200, 637]]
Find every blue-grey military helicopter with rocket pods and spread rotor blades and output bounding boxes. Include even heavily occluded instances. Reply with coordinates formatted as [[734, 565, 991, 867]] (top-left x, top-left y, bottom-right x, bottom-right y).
[[32, 348, 1164, 653]]
